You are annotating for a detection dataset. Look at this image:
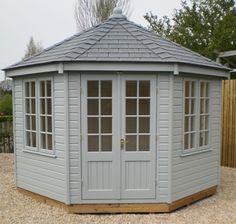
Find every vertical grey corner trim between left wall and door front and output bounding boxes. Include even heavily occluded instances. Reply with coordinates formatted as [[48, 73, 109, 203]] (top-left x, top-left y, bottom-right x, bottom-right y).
[[64, 73, 70, 205]]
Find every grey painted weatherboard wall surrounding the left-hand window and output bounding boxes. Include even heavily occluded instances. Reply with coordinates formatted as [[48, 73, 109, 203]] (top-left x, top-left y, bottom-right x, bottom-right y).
[[13, 74, 66, 202]]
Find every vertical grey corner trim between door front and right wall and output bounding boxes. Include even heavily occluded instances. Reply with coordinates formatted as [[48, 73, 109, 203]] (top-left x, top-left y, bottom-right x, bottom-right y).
[[168, 75, 174, 203]]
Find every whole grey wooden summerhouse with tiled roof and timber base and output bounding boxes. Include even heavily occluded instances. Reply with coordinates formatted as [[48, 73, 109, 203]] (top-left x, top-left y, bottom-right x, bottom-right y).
[[5, 9, 228, 212]]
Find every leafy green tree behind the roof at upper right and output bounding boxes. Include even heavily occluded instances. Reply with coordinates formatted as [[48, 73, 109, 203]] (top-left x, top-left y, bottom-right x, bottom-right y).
[[144, 0, 236, 59]]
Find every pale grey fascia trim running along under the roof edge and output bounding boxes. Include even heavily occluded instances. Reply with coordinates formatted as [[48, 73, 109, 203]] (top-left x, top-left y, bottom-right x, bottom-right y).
[[5, 61, 230, 78]]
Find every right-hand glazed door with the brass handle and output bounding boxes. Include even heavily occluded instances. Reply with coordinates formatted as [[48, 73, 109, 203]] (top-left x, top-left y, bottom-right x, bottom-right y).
[[121, 76, 156, 199]]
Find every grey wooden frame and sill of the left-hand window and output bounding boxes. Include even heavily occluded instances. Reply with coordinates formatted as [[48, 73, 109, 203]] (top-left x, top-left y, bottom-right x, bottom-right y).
[[23, 77, 55, 157]]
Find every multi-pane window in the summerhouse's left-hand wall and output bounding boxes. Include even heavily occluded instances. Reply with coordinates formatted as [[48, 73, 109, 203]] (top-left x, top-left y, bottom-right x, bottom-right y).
[[24, 80, 53, 152]]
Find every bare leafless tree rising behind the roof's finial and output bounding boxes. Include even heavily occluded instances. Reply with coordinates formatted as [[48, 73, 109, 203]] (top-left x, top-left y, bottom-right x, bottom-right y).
[[75, 0, 131, 31]]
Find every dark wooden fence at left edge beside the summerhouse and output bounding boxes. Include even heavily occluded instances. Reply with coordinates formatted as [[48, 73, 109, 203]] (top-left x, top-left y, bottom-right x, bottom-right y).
[[0, 116, 14, 153]]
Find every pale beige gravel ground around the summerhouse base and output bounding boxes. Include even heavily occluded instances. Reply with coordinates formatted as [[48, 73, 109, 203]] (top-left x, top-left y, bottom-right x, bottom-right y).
[[0, 154, 236, 224]]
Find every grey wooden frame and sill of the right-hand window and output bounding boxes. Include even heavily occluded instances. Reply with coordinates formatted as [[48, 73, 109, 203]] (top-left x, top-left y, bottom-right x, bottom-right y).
[[182, 78, 212, 155]]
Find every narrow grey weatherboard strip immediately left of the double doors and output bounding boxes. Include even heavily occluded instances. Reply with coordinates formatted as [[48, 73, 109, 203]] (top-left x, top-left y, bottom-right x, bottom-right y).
[[68, 72, 81, 204]]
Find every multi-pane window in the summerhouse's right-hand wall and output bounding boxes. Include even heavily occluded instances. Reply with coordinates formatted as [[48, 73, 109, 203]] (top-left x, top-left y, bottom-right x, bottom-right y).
[[184, 80, 210, 150]]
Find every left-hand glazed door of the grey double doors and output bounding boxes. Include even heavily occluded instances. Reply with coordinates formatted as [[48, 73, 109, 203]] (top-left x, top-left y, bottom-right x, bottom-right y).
[[81, 75, 120, 199]]
